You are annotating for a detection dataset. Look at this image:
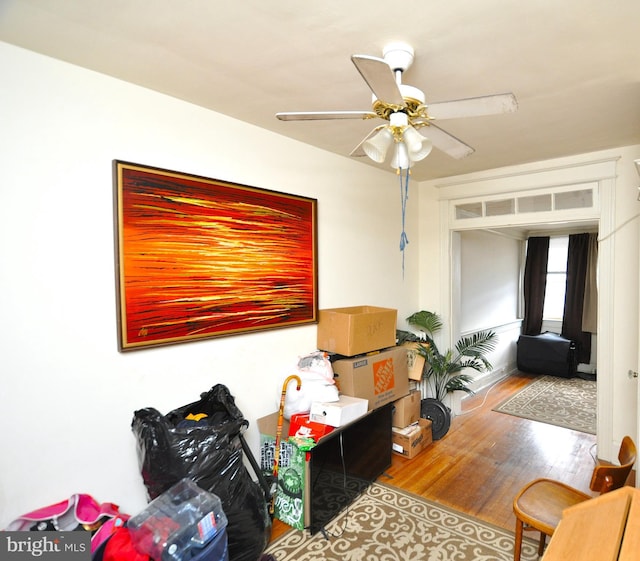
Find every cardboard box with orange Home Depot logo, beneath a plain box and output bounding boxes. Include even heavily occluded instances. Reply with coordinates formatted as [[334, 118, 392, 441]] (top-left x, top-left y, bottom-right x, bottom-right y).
[[332, 346, 409, 410]]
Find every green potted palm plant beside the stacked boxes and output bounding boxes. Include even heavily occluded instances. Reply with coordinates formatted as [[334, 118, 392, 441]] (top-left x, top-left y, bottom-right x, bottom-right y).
[[398, 310, 496, 440]]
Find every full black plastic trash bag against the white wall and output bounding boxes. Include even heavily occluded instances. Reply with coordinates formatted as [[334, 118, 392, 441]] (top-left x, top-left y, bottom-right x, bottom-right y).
[[131, 384, 271, 561]]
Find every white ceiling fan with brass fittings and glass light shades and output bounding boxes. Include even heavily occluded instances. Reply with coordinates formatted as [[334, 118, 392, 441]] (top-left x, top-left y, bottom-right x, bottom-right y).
[[276, 43, 518, 170]]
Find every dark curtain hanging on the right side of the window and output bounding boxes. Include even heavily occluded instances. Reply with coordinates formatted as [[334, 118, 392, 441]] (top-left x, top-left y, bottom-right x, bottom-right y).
[[562, 234, 591, 364]]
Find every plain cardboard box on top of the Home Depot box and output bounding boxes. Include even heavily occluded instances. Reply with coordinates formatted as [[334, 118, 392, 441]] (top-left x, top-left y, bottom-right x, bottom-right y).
[[318, 306, 398, 356]]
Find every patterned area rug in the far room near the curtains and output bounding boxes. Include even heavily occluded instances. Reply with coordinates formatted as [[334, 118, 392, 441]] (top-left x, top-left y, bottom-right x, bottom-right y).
[[494, 376, 597, 434]]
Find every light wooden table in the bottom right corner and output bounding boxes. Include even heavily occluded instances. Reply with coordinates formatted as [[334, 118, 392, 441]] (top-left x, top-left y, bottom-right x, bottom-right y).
[[543, 487, 640, 561]]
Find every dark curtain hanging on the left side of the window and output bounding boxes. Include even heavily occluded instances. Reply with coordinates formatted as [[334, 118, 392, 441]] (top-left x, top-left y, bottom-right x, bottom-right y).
[[522, 236, 549, 335]]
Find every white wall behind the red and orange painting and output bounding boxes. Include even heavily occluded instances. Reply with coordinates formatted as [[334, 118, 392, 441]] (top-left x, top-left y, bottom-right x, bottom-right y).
[[0, 43, 419, 528]]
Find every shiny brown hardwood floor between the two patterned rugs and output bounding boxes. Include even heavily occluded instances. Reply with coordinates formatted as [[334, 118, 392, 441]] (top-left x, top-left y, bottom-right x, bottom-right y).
[[272, 373, 596, 539]]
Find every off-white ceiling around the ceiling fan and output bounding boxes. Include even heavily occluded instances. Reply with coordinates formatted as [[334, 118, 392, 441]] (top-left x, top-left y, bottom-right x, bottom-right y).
[[0, 0, 640, 180]]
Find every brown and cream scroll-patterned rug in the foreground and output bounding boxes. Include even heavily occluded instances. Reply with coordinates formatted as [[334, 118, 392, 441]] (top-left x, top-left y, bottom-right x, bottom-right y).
[[266, 483, 537, 561]]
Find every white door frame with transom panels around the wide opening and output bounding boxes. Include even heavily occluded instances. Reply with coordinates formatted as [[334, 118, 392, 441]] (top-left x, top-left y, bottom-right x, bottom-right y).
[[438, 156, 615, 459]]
